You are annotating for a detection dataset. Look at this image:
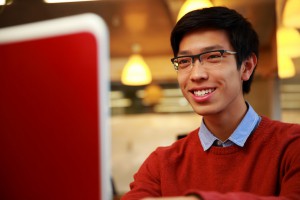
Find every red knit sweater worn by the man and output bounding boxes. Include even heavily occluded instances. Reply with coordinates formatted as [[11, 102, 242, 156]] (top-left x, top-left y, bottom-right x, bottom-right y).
[[122, 117, 300, 200]]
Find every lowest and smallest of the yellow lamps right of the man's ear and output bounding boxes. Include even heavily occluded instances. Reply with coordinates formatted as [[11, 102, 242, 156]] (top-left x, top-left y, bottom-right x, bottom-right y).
[[277, 55, 296, 79]]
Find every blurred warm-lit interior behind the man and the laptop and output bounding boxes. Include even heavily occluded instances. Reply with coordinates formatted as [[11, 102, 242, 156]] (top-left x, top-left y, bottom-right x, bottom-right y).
[[0, 0, 300, 195]]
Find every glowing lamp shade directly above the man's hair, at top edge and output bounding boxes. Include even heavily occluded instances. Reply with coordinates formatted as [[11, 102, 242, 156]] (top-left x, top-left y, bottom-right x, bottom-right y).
[[177, 0, 213, 21]]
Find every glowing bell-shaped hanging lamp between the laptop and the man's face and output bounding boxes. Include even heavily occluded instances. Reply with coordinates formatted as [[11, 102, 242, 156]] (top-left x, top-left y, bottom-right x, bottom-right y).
[[121, 54, 152, 86]]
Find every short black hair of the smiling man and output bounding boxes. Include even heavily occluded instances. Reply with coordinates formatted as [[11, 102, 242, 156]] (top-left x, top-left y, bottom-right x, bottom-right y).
[[170, 6, 259, 93]]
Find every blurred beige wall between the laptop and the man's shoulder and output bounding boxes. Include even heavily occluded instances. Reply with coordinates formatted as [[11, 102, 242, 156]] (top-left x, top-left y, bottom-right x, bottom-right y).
[[111, 113, 202, 194]]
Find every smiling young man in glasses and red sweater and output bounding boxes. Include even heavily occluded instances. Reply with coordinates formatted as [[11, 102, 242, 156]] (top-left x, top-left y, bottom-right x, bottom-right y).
[[122, 7, 300, 200]]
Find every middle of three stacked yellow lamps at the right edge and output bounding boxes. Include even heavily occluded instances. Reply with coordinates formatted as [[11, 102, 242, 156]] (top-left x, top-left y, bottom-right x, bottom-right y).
[[276, 27, 300, 58]]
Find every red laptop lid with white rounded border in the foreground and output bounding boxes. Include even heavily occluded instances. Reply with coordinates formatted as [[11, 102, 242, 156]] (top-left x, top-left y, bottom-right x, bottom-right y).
[[0, 13, 112, 200]]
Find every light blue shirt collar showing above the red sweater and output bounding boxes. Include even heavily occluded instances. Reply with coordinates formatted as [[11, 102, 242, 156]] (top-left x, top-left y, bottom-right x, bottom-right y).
[[198, 103, 261, 151]]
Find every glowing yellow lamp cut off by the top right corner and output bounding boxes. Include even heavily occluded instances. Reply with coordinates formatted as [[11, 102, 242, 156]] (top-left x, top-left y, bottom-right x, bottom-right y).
[[282, 0, 300, 28]]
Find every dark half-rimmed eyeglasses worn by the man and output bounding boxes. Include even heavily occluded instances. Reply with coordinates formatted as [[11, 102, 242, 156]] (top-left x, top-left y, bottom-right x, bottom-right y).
[[171, 50, 236, 72]]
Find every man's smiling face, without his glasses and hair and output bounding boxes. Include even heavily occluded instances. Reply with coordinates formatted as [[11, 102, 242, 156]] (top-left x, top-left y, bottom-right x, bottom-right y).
[[178, 29, 247, 117]]
